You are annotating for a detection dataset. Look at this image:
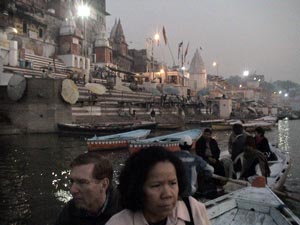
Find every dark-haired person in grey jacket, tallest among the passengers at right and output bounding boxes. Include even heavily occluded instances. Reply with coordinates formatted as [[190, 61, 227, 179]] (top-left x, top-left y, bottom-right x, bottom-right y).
[[228, 123, 249, 172]]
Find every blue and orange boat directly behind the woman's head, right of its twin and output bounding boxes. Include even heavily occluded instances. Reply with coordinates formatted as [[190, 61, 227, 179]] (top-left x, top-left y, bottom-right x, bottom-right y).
[[129, 129, 202, 153]]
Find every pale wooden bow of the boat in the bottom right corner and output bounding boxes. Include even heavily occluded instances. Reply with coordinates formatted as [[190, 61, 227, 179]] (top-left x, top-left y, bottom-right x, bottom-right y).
[[205, 186, 300, 225]]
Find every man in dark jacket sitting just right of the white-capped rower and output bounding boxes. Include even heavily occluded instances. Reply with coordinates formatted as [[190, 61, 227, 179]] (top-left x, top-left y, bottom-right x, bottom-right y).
[[196, 128, 225, 176]]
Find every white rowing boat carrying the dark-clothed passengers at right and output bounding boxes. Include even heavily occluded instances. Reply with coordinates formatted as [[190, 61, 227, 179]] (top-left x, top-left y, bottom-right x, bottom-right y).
[[220, 145, 291, 191]]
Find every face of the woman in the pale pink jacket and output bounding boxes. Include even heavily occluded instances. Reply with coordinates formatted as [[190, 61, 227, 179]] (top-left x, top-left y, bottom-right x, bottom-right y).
[[143, 161, 178, 223]]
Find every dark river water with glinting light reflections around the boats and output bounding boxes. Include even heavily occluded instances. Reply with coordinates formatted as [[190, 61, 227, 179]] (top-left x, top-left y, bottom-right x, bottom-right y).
[[0, 120, 300, 225]]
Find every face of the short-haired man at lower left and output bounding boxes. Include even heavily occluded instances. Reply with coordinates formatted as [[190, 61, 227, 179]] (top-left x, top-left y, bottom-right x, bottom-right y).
[[70, 164, 109, 213]]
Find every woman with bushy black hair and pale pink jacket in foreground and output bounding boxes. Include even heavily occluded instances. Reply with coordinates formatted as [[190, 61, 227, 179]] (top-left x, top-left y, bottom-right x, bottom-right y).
[[107, 146, 210, 225]]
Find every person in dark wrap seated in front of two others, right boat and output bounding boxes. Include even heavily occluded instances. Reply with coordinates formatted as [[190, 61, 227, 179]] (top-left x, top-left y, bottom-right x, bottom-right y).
[[240, 136, 271, 182]]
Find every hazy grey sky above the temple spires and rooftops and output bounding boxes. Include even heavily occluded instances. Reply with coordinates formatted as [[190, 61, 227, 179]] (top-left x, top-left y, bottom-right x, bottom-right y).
[[106, 0, 300, 83]]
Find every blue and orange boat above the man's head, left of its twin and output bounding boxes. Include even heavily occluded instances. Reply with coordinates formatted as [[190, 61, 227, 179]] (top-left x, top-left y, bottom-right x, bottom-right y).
[[86, 129, 151, 151]]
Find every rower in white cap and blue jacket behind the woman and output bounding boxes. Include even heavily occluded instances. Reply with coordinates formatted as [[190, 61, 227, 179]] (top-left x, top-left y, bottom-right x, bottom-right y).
[[174, 135, 214, 195]]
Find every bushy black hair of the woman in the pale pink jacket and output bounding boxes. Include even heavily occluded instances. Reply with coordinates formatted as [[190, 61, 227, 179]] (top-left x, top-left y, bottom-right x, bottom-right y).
[[119, 146, 186, 212]]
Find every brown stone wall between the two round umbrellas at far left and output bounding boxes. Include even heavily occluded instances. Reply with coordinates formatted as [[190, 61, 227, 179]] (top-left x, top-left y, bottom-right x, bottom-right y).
[[0, 79, 72, 133]]
